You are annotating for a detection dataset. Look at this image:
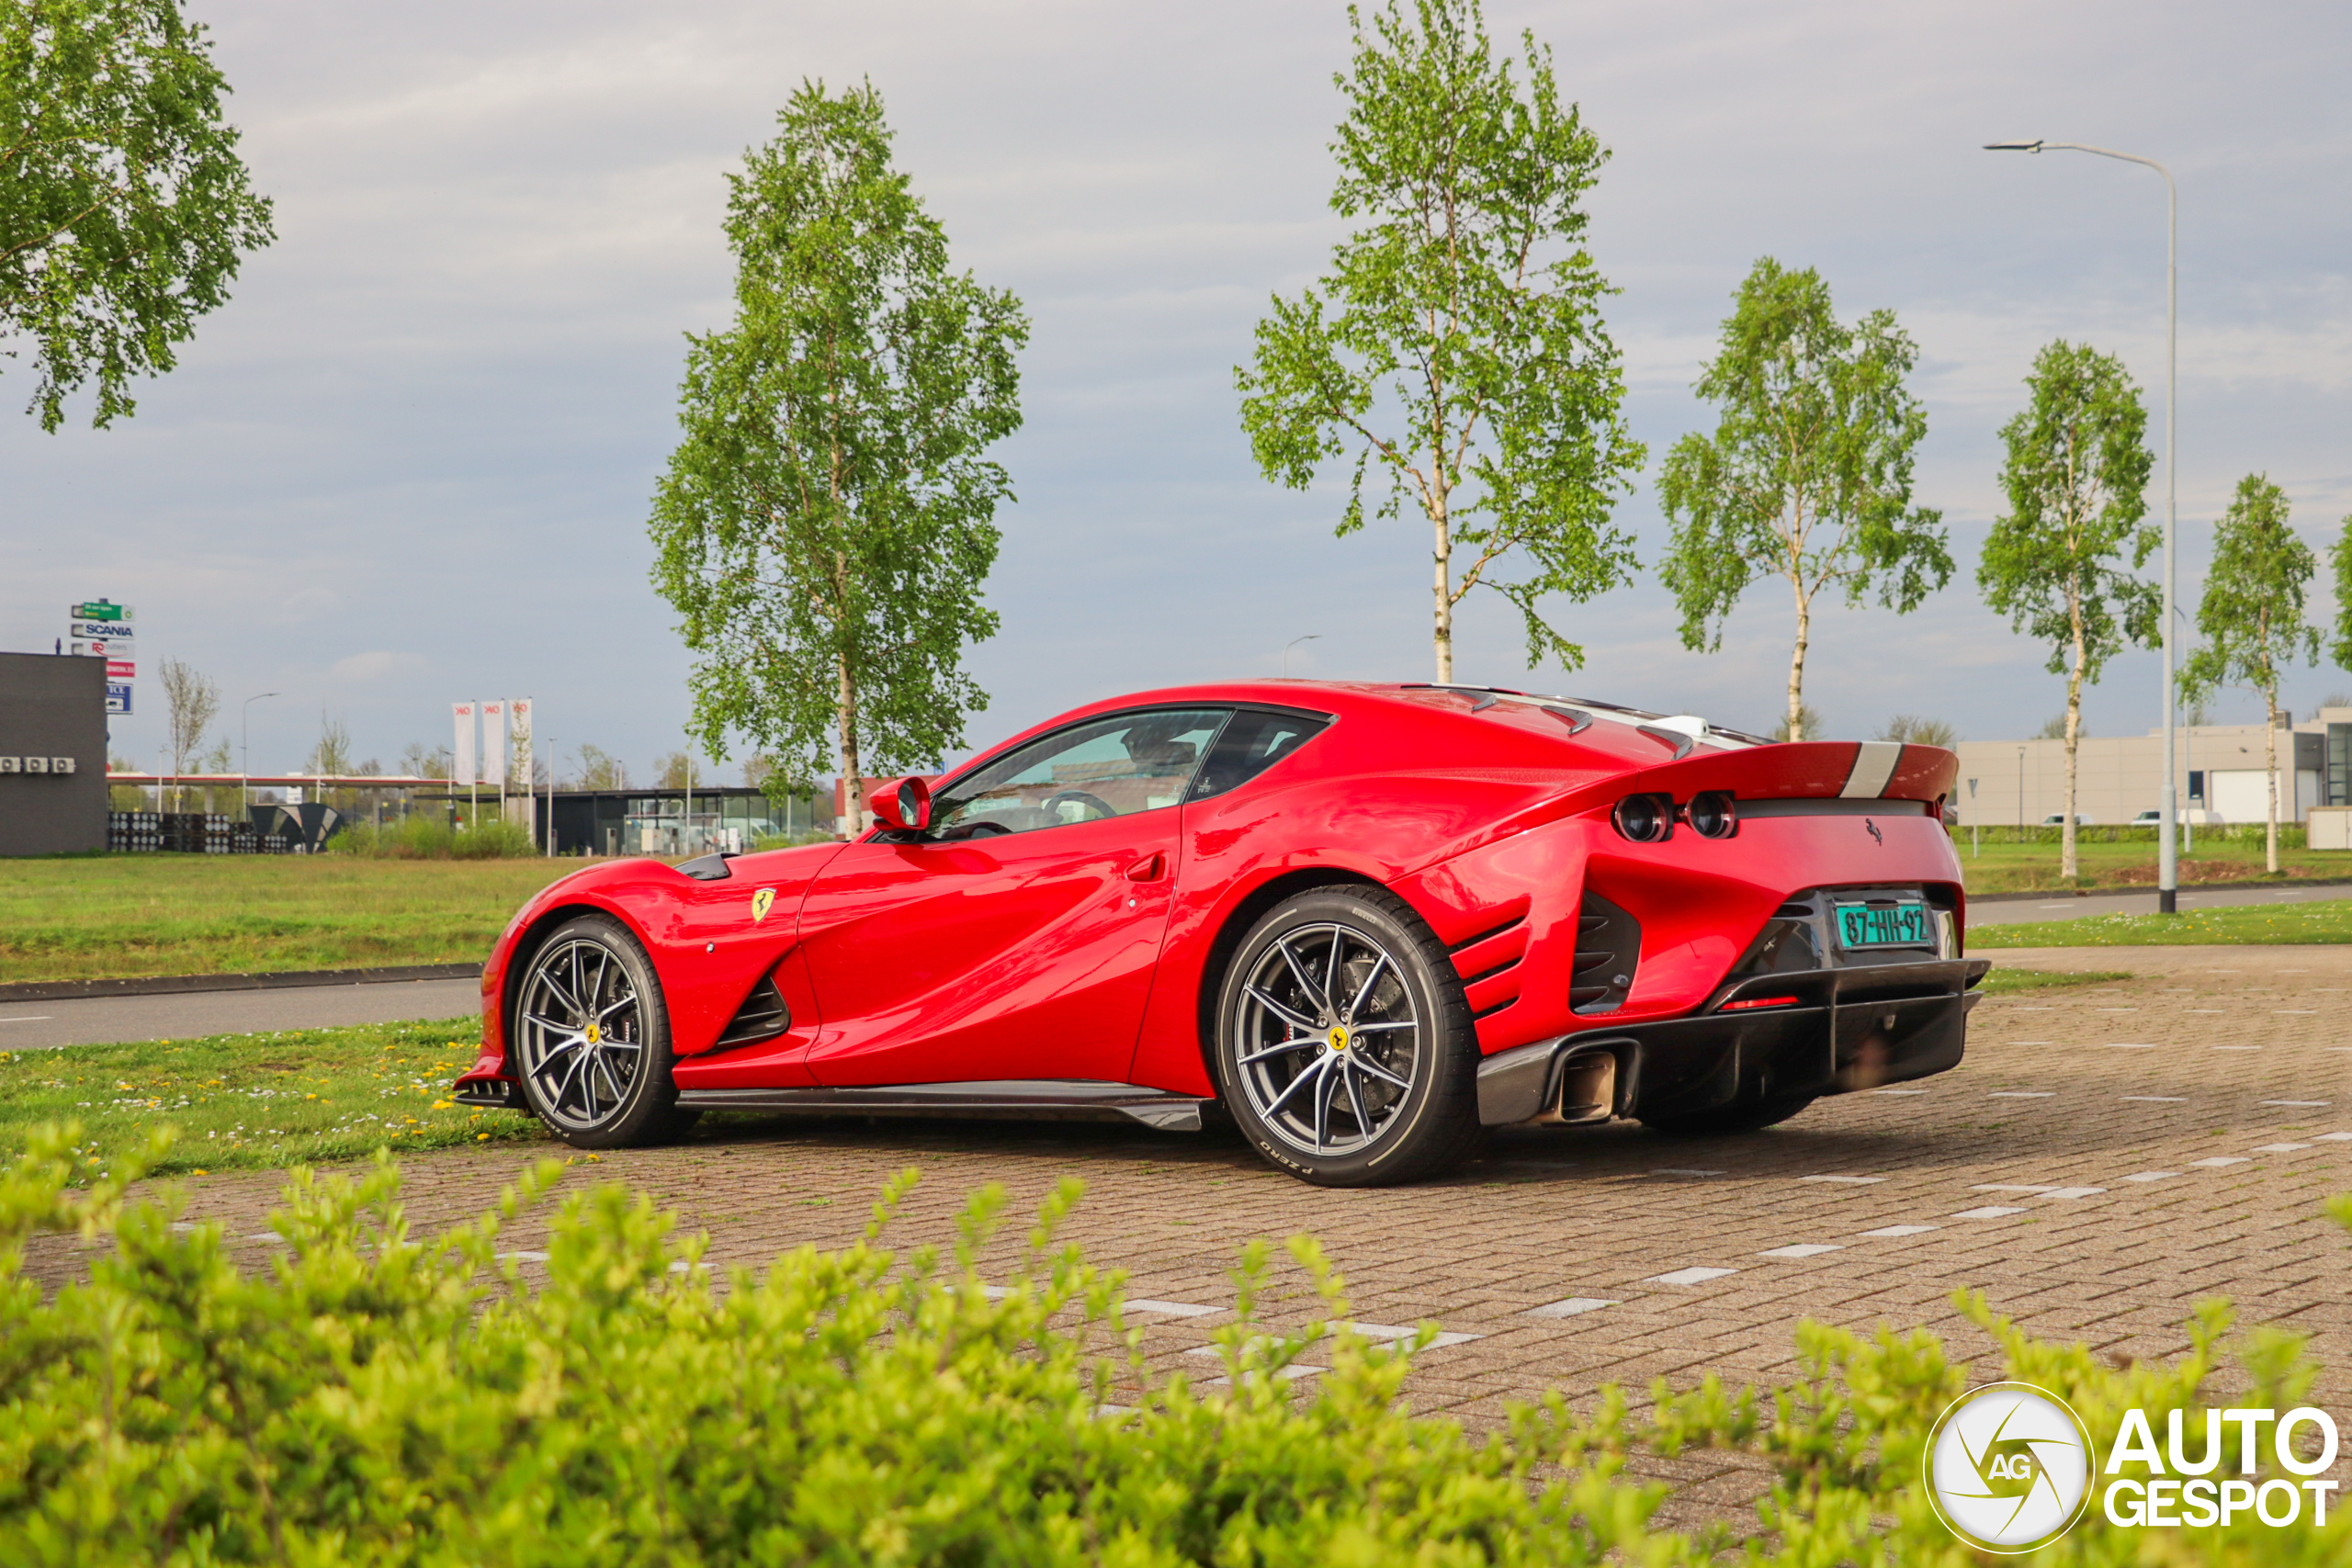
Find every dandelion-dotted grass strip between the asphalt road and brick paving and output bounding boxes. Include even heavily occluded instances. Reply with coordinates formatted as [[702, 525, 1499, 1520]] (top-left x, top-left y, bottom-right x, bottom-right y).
[[0, 1018, 546, 1182]]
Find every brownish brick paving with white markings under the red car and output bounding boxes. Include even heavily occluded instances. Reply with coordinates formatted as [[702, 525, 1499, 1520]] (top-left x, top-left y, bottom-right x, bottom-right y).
[[55, 947, 2352, 1514]]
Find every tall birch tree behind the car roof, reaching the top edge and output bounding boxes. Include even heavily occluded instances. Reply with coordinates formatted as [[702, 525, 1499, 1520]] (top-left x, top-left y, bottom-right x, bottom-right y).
[[1232, 0, 1644, 680]]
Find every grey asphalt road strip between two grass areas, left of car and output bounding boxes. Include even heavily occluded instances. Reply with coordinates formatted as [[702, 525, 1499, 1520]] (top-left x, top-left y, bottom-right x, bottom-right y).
[[0, 978, 482, 1051]]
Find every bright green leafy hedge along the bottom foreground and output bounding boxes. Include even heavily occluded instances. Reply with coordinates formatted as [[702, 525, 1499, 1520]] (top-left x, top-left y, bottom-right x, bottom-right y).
[[0, 1128, 2352, 1568]]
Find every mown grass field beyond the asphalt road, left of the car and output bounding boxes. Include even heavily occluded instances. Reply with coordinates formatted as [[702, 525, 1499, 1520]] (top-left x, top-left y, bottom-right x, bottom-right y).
[[0, 856, 583, 983]]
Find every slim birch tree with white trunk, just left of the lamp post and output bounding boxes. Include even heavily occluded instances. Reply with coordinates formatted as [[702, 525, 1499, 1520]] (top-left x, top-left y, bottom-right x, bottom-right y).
[[1975, 339, 2164, 882]]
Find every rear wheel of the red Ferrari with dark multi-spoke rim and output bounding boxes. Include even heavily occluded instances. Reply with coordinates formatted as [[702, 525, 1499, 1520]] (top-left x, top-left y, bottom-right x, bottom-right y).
[[1211, 886, 1479, 1187]]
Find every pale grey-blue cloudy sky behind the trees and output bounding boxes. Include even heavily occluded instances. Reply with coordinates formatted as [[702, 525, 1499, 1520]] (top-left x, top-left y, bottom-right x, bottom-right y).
[[0, 0, 2352, 778]]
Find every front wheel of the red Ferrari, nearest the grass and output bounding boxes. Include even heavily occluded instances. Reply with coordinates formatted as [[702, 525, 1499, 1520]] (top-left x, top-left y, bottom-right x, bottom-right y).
[[508, 915, 696, 1149]]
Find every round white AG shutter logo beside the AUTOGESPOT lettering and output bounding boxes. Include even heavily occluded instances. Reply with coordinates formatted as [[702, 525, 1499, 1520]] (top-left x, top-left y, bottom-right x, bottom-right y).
[[1924, 1382, 2093, 1554]]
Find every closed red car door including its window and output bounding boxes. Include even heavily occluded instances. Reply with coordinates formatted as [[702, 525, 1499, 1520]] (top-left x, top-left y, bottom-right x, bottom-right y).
[[799, 707, 1226, 1086]]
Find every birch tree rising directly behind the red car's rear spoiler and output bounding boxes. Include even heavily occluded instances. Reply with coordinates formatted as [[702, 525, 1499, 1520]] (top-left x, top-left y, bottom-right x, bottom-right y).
[[1658, 256, 1952, 740]]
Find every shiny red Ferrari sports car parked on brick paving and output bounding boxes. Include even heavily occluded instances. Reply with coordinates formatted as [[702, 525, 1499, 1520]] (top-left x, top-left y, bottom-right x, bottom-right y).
[[457, 682, 1987, 1185]]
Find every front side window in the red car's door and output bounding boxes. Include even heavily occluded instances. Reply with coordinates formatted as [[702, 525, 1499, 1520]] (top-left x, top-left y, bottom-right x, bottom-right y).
[[932, 707, 1226, 840]]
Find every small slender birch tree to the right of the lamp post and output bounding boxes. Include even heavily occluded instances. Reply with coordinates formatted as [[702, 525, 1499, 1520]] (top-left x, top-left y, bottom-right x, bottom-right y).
[[2180, 472, 2319, 872]]
